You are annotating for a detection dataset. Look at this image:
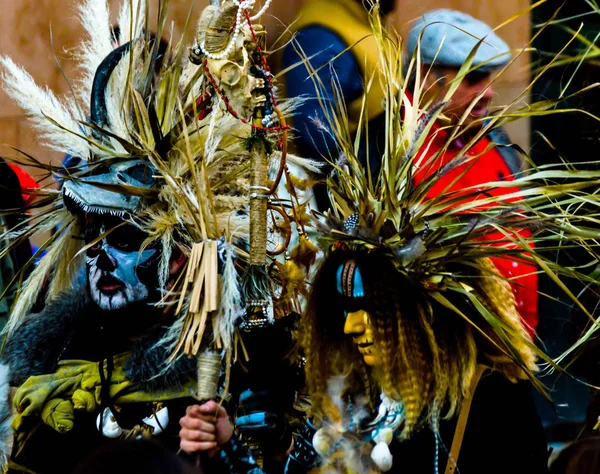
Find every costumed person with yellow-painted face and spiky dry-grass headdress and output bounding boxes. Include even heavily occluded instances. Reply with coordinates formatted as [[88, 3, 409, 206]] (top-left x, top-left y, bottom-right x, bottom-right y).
[[181, 4, 597, 474]]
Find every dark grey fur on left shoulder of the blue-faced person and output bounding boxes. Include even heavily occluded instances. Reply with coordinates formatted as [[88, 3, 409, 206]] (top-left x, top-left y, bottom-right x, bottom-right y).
[[1, 291, 89, 386]]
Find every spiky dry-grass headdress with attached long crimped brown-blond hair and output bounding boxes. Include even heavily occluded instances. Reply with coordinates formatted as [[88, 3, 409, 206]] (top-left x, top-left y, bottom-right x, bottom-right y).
[[301, 2, 600, 460]]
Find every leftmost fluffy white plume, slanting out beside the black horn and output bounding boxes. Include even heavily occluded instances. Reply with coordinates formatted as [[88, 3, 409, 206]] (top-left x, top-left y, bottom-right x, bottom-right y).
[[0, 56, 89, 158]]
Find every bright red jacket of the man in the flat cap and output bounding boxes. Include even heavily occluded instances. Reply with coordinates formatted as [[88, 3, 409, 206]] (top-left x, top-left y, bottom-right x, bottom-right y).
[[414, 126, 539, 335]]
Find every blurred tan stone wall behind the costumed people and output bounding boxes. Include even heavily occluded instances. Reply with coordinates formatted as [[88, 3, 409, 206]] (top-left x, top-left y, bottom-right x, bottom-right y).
[[0, 0, 532, 165]]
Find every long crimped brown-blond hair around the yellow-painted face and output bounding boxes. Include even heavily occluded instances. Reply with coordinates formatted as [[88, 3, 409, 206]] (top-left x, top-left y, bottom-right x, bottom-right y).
[[300, 250, 535, 438]]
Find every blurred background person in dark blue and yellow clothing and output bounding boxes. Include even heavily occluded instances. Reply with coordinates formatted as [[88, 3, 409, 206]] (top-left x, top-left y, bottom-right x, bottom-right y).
[[281, 0, 396, 210]]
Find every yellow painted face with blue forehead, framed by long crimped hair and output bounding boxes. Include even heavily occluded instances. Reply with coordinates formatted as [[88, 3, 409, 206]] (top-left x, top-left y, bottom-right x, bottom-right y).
[[336, 260, 379, 367]]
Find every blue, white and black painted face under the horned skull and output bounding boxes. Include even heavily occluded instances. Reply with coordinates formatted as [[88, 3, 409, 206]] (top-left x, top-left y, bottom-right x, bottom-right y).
[[85, 214, 158, 311]]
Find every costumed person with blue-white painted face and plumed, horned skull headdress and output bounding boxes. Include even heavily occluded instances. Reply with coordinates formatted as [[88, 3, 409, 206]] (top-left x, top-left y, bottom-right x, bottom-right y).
[[0, 0, 310, 474]]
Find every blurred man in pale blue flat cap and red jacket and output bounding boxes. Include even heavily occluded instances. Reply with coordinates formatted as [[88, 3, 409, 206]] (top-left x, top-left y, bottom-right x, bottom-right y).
[[407, 9, 538, 335]]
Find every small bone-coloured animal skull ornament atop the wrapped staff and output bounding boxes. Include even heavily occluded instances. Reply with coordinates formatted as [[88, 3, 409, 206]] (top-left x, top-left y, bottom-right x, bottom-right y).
[[192, 1, 267, 120]]
